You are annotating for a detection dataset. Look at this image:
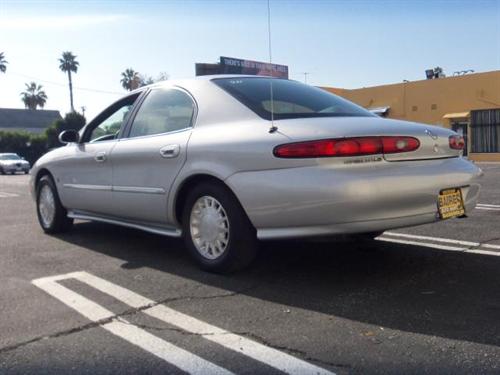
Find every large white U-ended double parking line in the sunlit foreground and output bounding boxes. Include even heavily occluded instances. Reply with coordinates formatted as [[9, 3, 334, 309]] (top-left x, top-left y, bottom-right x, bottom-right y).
[[32, 272, 333, 375]]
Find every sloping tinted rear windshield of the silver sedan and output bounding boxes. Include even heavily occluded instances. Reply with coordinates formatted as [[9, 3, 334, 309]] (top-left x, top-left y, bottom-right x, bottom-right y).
[[212, 77, 374, 120]]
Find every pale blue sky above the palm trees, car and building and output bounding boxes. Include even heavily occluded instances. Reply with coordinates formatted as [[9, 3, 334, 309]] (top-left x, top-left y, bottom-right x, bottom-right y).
[[0, 0, 500, 117]]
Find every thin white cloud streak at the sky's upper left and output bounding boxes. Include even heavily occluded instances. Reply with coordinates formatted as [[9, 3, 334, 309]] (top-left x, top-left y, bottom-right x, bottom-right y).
[[0, 14, 127, 30]]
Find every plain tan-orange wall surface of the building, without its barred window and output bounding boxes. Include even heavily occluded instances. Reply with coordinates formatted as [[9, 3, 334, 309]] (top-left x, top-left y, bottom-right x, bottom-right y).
[[323, 70, 500, 161]]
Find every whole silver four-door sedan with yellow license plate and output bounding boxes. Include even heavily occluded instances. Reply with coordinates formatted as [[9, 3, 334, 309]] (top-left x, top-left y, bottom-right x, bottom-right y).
[[31, 76, 482, 272]]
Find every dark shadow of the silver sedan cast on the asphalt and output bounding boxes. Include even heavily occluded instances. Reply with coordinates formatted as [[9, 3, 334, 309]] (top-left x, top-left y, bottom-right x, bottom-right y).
[[58, 223, 500, 346]]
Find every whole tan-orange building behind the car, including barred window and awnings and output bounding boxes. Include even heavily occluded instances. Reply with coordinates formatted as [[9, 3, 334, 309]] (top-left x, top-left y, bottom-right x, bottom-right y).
[[324, 70, 500, 161]]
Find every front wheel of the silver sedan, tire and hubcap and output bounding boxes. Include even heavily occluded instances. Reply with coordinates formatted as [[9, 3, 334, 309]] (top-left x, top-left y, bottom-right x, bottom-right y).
[[36, 175, 73, 234]]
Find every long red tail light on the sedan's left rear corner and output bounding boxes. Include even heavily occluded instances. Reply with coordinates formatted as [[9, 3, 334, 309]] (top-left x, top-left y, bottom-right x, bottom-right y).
[[273, 136, 420, 158]]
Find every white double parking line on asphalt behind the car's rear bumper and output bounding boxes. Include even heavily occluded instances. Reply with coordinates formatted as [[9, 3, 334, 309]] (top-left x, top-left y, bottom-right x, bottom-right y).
[[376, 232, 500, 256]]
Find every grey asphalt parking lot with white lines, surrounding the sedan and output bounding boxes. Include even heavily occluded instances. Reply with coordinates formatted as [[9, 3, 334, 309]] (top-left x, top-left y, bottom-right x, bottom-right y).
[[0, 164, 500, 374]]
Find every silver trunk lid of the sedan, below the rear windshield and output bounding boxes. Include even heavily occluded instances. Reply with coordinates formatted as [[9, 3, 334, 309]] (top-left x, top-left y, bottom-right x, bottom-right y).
[[275, 117, 460, 161]]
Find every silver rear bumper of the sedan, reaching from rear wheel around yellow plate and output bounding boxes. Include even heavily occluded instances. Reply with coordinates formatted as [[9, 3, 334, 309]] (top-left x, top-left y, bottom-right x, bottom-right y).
[[226, 158, 482, 239]]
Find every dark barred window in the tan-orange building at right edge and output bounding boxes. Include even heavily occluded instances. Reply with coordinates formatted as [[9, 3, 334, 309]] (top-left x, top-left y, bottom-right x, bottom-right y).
[[471, 109, 500, 152]]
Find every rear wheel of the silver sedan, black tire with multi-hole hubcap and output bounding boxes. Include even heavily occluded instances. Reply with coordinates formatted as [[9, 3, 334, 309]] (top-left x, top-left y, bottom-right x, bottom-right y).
[[182, 183, 258, 273]]
